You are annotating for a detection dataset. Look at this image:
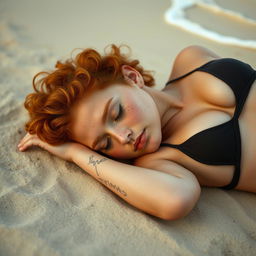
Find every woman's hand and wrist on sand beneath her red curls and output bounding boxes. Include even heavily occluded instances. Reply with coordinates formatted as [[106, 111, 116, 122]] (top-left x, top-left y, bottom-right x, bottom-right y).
[[18, 133, 86, 161]]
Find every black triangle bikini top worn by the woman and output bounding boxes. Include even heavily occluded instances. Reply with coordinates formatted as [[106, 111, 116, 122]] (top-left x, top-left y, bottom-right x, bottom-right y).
[[161, 58, 256, 189]]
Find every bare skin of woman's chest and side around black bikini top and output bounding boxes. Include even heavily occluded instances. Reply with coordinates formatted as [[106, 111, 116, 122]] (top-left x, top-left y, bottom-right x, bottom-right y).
[[157, 58, 256, 192]]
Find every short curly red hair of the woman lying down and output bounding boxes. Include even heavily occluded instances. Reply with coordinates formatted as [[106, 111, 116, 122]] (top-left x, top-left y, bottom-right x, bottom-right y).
[[24, 44, 154, 145]]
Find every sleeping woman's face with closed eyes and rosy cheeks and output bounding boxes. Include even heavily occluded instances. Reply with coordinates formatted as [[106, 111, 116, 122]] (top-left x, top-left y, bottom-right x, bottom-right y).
[[71, 77, 162, 159]]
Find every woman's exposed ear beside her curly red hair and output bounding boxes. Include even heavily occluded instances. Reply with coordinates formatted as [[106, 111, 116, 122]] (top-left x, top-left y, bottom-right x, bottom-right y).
[[121, 65, 145, 88]]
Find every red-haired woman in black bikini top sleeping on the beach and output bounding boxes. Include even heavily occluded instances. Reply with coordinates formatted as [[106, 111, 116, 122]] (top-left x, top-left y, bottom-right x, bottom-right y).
[[18, 45, 256, 220]]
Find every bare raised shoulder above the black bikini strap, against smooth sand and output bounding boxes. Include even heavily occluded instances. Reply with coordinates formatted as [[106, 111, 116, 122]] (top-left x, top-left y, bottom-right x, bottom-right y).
[[169, 45, 220, 79]]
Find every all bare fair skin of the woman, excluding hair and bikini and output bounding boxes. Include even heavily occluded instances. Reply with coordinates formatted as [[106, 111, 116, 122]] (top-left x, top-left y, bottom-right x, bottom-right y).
[[19, 46, 256, 220]]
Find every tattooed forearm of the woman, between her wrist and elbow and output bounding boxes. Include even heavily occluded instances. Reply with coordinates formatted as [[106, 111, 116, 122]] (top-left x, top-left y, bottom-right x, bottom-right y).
[[72, 147, 193, 218]]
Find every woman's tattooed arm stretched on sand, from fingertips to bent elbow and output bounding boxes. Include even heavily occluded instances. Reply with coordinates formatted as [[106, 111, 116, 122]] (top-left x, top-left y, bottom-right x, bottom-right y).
[[19, 135, 200, 220]]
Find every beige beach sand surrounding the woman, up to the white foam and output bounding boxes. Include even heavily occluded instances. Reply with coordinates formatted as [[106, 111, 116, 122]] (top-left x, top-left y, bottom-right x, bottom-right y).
[[0, 0, 256, 256]]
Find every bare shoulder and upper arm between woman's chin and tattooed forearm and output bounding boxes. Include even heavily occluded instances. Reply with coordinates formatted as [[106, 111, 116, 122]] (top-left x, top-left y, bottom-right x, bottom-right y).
[[134, 148, 198, 180]]
